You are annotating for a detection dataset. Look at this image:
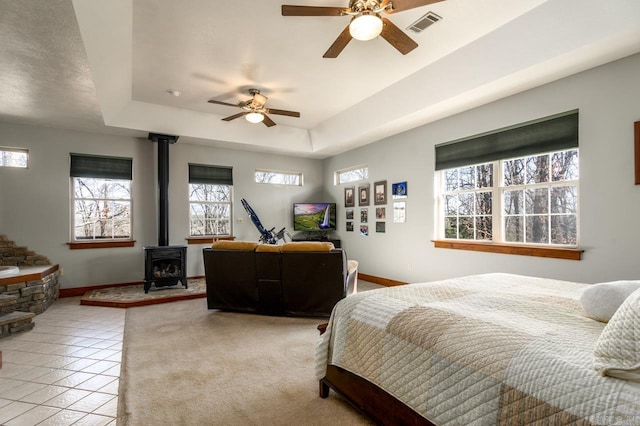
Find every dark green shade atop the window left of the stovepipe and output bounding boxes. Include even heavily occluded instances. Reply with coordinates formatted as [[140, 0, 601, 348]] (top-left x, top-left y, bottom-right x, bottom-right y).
[[71, 154, 133, 180]]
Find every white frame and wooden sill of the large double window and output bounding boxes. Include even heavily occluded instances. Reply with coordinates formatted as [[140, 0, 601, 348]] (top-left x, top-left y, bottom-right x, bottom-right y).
[[433, 147, 584, 260]]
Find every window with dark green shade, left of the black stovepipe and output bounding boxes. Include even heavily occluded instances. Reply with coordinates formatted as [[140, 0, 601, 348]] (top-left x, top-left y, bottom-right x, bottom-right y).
[[71, 154, 132, 242]]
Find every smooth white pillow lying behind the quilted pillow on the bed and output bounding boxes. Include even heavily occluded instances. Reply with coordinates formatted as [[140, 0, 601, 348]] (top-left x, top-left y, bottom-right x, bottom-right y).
[[580, 281, 640, 322]]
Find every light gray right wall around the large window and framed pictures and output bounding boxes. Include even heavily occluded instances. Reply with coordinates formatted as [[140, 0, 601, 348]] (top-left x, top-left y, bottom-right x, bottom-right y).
[[324, 55, 640, 282]]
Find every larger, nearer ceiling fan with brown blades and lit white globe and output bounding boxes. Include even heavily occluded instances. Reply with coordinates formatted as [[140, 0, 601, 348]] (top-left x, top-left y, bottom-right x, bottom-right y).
[[282, 0, 443, 58]]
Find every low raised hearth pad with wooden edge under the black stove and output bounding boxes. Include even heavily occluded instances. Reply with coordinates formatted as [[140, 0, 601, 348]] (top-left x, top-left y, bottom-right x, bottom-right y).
[[80, 278, 207, 308]]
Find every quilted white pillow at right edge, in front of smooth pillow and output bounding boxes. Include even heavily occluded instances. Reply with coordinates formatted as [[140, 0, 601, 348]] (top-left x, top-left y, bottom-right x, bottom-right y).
[[593, 290, 640, 382]]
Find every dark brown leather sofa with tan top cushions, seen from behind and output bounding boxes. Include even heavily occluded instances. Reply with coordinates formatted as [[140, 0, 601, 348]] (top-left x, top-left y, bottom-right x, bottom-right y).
[[203, 241, 358, 317]]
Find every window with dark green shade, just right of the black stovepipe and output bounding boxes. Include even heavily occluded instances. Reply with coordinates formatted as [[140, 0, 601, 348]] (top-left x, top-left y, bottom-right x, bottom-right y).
[[189, 164, 233, 237]]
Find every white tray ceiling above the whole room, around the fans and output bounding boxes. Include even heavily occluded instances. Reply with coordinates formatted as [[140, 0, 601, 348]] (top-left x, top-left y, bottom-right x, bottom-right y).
[[0, 0, 640, 158]]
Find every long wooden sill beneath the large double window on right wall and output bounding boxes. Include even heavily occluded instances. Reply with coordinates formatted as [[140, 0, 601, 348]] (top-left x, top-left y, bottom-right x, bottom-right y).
[[433, 240, 584, 260]]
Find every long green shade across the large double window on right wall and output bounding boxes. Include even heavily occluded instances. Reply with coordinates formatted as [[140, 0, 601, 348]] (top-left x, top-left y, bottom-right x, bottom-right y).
[[435, 110, 578, 170]]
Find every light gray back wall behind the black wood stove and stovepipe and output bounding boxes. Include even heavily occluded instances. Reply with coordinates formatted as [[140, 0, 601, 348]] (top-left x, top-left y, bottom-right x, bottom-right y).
[[0, 123, 322, 288]]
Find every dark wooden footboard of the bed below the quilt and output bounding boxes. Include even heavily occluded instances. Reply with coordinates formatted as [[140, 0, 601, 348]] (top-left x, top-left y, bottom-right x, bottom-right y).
[[319, 365, 436, 426]]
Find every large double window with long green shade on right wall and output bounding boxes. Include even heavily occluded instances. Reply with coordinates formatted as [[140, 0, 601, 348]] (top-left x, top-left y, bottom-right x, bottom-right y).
[[436, 111, 579, 247]]
